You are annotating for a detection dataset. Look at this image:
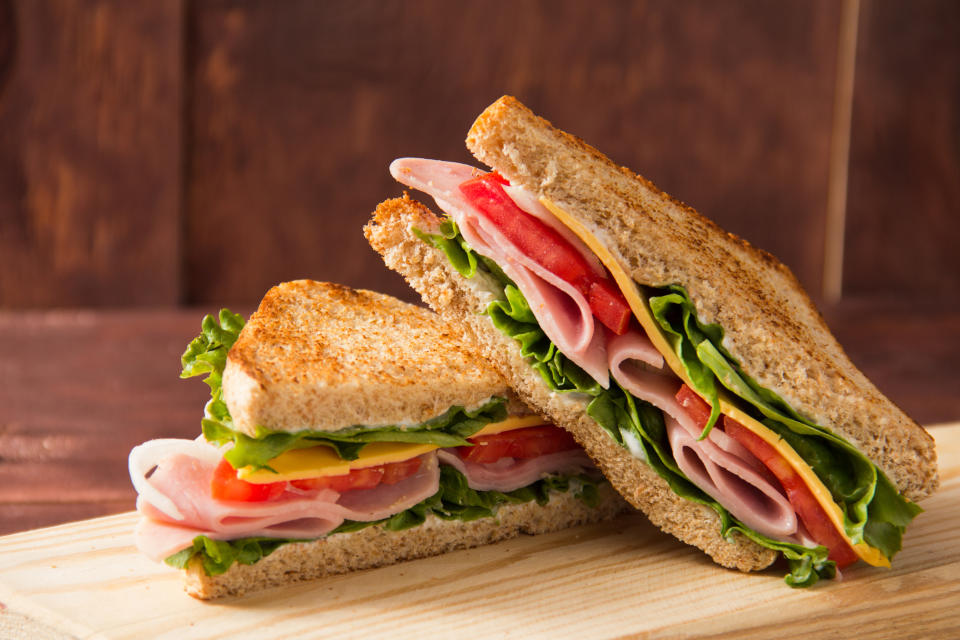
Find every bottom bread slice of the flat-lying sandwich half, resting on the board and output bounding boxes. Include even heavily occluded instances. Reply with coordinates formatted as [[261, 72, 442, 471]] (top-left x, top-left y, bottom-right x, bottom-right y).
[[184, 483, 626, 600]]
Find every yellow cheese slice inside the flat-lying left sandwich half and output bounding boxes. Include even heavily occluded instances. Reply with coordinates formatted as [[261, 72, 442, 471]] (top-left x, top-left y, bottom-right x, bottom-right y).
[[237, 416, 544, 484]]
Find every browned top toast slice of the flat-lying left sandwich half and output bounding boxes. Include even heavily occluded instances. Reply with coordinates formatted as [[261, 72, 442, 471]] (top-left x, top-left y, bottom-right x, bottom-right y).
[[223, 280, 512, 436]]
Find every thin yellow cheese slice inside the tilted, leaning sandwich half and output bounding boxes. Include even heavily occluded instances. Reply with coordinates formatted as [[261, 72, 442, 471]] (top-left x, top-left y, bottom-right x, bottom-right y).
[[540, 198, 890, 567]]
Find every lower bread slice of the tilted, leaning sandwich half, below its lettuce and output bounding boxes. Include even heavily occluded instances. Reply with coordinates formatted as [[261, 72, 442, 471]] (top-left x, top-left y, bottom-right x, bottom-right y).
[[364, 195, 777, 571]]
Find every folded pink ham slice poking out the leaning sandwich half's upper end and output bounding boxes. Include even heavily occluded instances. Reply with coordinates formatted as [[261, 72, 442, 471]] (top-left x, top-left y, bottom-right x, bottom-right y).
[[390, 158, 609, 388]]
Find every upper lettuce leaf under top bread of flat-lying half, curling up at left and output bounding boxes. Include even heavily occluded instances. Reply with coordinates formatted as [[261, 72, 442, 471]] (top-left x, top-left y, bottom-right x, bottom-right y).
[[180, 309, 507, 469]]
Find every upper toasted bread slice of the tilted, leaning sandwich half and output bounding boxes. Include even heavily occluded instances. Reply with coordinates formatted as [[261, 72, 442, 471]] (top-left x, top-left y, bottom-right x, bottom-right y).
[[467, 96, 939, 500]]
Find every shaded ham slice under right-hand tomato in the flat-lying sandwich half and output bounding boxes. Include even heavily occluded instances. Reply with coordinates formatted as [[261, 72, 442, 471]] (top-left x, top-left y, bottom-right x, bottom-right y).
[[438, 448, 595, 492]]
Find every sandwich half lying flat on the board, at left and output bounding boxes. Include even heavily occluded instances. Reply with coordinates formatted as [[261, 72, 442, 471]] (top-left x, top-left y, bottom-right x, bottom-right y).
[[129, 280, 626, 599]]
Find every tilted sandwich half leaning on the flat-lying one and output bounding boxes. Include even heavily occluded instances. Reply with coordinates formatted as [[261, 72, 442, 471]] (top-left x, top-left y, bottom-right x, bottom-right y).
[[365, 97, 938, 586]]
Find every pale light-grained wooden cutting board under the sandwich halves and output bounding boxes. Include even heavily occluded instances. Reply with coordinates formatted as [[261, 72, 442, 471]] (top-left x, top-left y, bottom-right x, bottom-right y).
[[0, 423, 960, 640]]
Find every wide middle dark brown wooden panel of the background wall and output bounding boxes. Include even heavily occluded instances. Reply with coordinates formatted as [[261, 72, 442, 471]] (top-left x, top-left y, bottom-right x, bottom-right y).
[[186, 0, 839, 302]]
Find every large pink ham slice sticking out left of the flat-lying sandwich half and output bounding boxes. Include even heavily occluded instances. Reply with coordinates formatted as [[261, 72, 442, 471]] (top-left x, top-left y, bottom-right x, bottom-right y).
[[134, 441, 440, 559]]
